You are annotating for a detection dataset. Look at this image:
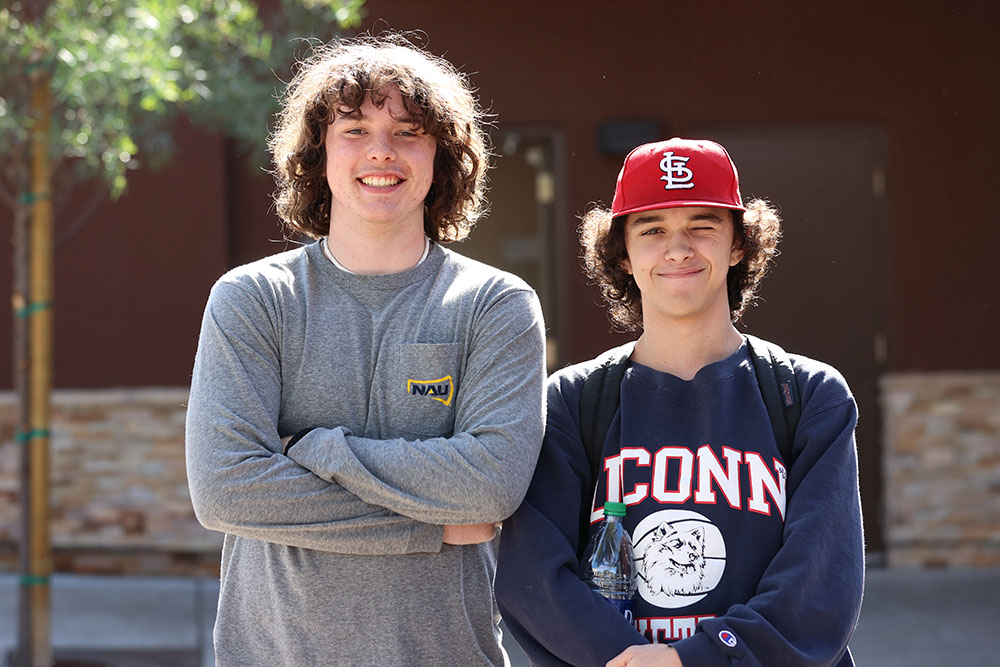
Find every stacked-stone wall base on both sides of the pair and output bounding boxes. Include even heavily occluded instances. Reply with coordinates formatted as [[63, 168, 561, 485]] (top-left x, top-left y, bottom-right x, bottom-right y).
[[0, 380, 1000, 574]]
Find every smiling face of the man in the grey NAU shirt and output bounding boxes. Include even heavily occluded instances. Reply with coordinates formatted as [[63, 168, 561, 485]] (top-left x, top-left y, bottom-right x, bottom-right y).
[[325, 86, 437, 235]]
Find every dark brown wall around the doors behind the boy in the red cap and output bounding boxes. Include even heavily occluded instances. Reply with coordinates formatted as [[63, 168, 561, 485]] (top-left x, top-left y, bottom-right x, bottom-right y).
[[358, 0, 1000, 371]]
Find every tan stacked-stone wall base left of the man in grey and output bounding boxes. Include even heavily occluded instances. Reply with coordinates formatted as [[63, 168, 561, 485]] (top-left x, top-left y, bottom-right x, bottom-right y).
[[0, 388, 222, 574]]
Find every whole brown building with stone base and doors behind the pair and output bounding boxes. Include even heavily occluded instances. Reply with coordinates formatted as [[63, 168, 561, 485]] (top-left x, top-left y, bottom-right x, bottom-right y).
[[0, 0, 1000, 574]]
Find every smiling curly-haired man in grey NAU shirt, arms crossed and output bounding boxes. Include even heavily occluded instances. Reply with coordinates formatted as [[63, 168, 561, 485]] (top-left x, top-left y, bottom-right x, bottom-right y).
[[187, 36, 545, 667]]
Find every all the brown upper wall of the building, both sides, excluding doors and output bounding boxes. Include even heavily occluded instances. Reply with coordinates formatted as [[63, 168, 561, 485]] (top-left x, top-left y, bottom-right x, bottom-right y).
[[0, 0, 1000, 387]]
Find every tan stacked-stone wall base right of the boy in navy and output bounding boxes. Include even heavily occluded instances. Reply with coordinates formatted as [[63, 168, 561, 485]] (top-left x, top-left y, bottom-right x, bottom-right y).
[[882, 372, 1000, 567]]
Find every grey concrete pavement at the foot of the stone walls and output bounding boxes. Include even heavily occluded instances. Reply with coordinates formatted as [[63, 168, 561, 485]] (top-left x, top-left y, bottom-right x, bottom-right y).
[[0, 569, 1000, 667]]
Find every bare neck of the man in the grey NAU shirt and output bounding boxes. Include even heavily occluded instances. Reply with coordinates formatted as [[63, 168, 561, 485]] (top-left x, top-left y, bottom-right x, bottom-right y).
[[327, 221, 426, 275]]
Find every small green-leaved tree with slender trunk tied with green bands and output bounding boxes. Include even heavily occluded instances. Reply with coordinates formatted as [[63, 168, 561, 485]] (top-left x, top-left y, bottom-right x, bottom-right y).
[[0, 0, 364, 666]]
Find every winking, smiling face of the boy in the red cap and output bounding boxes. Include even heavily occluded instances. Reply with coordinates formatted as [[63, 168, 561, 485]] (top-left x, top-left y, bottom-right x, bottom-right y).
[[622, 206, 743, 330]]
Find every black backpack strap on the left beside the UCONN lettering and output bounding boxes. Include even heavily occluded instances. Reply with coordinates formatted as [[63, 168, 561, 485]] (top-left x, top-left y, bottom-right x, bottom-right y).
[[577, 341, 635, 554]]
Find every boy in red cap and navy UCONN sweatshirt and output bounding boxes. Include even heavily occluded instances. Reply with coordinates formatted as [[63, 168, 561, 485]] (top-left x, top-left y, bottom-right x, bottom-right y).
[[496, 139, 864, 667]]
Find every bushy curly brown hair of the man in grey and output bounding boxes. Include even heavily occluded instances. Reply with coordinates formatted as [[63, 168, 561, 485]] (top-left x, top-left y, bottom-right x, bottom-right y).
[[268, 33, 490, 242]]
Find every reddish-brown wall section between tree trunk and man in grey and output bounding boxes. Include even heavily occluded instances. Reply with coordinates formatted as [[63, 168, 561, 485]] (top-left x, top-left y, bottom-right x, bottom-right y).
[[0, 120, 228, 389]]
